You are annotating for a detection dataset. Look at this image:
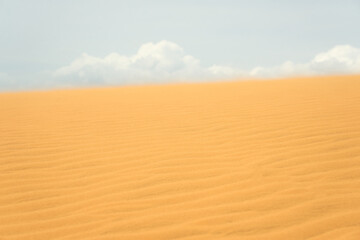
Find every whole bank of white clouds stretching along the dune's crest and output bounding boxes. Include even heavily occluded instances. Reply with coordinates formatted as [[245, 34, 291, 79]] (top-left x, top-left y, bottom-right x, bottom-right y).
[[53, 41, 360, 86]]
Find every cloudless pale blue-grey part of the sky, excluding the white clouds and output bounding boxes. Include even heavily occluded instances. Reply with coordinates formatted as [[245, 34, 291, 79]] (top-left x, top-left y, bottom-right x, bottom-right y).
[[0, 0, 360, 91]]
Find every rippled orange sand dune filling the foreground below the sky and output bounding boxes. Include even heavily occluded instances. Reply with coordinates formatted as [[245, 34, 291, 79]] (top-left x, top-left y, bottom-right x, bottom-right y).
[[0, 76, 360, 240]]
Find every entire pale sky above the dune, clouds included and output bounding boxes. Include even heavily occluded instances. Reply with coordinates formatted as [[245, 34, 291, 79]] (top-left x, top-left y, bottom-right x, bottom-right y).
[[0, 0, 360, 91]]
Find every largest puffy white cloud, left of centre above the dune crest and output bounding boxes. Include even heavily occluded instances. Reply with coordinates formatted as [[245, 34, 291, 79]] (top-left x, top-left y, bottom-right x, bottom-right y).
[[54, 41, 228, 84]]
